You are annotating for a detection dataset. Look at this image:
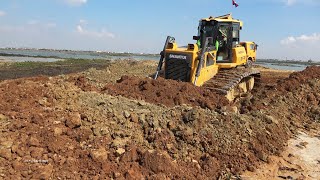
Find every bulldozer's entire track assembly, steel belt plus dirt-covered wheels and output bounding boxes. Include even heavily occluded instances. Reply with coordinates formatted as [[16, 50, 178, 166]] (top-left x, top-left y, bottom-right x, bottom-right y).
[[203, 68, 260, 101]]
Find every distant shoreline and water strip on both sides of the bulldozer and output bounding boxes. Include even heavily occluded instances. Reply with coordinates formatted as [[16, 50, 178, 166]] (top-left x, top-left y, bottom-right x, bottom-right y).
[[0, 48, 320, 70]]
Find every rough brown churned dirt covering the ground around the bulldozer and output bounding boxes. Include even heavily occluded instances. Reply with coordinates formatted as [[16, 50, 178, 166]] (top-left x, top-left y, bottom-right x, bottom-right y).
[[0, 61, 320, 179]]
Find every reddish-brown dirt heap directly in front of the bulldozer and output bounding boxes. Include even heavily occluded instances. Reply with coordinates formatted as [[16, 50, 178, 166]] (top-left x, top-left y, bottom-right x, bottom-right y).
[[102, 76, 228, 109]]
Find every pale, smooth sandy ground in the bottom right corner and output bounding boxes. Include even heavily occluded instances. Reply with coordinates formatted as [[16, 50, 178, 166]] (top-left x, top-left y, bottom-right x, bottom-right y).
[[241, 132, 320, 180]]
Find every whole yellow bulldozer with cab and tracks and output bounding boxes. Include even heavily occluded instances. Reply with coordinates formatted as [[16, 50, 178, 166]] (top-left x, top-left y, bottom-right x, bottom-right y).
[[154, 14, 260, 101]]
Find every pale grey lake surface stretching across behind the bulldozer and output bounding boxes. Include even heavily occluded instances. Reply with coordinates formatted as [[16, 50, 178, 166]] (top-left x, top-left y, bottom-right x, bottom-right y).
[[0, 49, 314, 71]]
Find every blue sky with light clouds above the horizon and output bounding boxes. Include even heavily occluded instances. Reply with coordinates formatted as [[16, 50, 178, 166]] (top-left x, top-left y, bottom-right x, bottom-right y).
[[0, 0, 320, 61]]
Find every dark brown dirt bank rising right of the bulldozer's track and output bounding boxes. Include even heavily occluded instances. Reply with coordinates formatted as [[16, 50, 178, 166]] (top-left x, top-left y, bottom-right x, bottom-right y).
[[239, 66, 320, 131]]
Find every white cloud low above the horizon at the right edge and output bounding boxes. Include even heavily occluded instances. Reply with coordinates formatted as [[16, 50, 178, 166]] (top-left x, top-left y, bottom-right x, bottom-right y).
[[280, 33, 320, 45]]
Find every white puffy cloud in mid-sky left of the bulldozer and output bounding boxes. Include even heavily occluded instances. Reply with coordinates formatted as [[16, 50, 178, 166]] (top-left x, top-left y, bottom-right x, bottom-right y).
[[76, 20, 115, 39]]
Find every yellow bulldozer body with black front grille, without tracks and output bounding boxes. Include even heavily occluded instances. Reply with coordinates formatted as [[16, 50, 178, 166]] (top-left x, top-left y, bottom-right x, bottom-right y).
[[164, 14, 257, 86]]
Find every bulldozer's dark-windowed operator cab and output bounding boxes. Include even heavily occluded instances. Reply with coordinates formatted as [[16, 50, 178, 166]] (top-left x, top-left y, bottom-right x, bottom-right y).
[[194, 18, 241, 63]]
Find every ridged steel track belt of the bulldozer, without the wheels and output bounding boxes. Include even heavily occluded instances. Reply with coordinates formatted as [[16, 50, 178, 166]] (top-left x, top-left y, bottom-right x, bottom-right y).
[[203, 68, 260, 94]]
